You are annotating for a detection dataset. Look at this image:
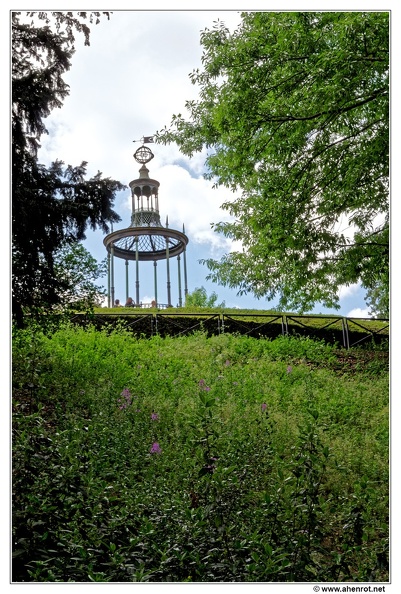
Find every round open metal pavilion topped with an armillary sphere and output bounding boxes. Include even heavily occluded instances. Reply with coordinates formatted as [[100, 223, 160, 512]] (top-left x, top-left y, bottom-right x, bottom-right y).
[[103, 137, 188, 307]]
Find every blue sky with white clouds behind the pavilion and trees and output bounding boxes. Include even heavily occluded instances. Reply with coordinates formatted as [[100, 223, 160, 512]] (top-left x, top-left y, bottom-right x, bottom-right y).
[[20, 7, 390, 317]]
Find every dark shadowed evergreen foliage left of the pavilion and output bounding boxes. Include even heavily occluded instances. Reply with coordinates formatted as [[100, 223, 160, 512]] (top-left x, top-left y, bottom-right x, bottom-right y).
[[12, 12, 124, 323]]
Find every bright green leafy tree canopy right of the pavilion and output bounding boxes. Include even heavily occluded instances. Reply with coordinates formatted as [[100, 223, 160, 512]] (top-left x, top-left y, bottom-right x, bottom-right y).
[[157, 12, 389, 311]]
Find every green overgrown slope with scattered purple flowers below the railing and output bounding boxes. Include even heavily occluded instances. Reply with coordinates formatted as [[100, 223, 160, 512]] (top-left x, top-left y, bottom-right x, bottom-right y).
[[12, 324, 389, 582]]
